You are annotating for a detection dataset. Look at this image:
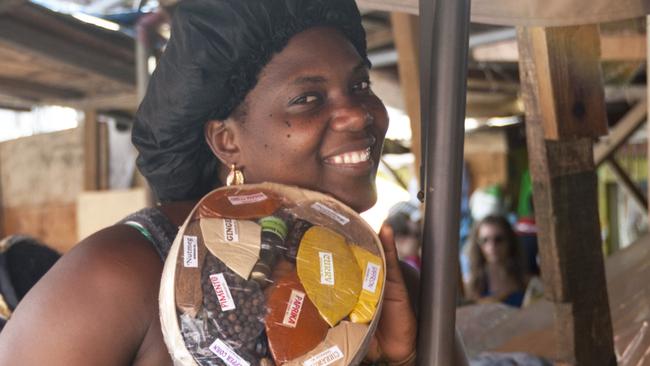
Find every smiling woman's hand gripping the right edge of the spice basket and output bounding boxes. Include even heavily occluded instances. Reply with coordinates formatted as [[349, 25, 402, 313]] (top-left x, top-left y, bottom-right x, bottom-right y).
[[366, 224, 417, 364]]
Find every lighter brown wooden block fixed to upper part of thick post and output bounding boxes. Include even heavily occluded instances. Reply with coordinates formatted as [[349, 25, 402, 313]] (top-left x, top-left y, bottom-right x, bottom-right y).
[[529, 25, 607, 140]]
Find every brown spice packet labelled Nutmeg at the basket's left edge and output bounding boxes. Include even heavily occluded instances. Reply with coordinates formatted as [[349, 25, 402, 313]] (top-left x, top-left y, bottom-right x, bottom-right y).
[[175, 221, 207, 317]]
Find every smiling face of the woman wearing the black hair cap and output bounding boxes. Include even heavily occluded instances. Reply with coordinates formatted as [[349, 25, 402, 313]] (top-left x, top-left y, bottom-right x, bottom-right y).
[[208, 27, 388, 211]]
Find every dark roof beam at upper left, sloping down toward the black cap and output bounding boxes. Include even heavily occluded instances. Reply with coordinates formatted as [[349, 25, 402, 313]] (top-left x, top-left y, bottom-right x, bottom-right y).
[[0, 17, 135, 85]]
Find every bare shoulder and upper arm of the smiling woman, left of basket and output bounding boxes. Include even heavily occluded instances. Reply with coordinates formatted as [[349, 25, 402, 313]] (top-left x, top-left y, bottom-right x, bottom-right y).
[[0, 226, 171, 366]]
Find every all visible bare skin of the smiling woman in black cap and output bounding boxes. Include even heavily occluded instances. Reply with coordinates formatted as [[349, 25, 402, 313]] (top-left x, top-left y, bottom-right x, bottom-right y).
[[0, 28, 416, 366]]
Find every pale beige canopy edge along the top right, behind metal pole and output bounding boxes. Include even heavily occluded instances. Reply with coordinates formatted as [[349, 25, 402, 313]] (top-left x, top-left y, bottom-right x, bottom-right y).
[[357, 0, 650, 26]]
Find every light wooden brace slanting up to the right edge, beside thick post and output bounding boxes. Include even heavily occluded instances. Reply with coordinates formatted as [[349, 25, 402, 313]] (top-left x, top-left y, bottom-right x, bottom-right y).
[[594, 100, 648, 166]]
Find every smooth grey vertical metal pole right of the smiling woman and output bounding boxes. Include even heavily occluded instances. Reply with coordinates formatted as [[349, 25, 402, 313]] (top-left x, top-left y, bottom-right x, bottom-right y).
[[417, 0, 470, 366]]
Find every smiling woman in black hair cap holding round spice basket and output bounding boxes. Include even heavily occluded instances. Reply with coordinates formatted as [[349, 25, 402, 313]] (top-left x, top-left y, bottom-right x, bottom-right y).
[[0, 0, 416, 366]]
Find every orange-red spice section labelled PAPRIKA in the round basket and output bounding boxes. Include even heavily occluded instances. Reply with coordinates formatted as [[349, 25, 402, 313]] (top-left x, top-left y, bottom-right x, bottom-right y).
[[264, 271, 329, 365]]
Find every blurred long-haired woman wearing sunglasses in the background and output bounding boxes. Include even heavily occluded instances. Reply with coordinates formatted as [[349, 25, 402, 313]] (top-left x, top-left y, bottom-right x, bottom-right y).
[[466, 215, 528, 307]]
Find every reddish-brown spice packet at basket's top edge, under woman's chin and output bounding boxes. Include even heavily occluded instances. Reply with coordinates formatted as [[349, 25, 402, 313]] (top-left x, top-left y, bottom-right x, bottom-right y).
[[195, 187, 282, 220]]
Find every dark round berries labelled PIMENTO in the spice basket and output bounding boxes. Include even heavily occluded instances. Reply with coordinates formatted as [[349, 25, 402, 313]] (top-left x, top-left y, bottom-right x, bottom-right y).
[[201, 255, 266, 349]]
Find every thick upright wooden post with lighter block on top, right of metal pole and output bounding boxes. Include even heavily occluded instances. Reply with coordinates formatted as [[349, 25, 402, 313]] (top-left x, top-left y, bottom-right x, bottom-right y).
[[518, 26, 616, 366]]
